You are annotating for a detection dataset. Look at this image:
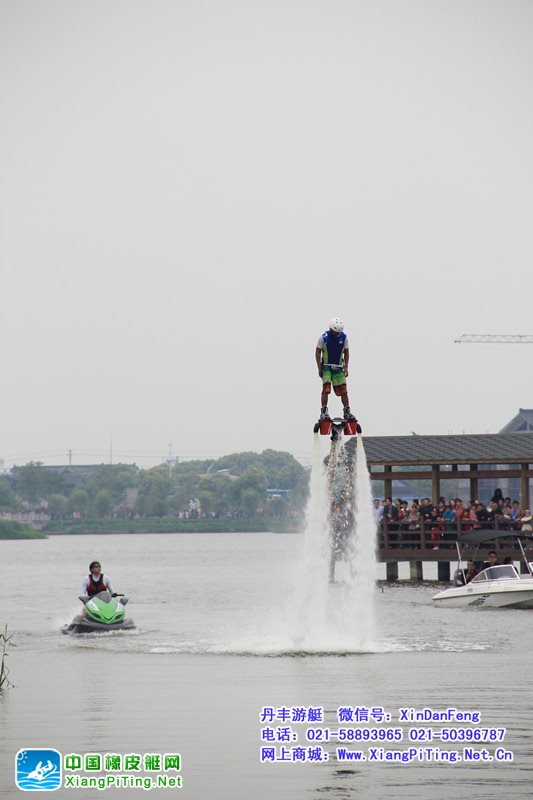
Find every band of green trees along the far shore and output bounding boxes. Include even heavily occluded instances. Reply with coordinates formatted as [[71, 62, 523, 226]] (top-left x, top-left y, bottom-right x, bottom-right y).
[[0, 450, 308, 520]]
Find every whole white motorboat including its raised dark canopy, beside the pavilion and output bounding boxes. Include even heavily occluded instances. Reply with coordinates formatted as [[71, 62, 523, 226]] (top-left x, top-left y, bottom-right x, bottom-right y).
[[433, 531, 533, 608]]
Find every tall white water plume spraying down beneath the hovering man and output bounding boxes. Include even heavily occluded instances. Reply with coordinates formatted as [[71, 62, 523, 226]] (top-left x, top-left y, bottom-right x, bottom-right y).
[[286, 436, 377, 653]]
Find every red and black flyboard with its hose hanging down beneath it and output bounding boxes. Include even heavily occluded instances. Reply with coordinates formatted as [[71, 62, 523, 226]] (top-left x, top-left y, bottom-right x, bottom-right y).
[[313, 417, 361, 582]]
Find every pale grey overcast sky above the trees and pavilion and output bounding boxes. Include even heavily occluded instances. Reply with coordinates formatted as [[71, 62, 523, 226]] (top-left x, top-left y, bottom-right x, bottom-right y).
[[0, 0, 533, 468]]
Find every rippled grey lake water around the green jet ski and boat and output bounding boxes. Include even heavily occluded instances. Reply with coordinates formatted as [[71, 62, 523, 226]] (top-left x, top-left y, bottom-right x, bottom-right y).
[[0, 534, 533, 800]]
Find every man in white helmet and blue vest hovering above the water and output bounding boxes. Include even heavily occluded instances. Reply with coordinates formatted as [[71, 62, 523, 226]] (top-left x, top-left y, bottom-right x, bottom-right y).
[[315, 317, 360, 432]]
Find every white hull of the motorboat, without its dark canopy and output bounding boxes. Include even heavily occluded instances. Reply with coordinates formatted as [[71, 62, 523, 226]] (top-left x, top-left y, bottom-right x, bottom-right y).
[[433, 564, 533, 608]]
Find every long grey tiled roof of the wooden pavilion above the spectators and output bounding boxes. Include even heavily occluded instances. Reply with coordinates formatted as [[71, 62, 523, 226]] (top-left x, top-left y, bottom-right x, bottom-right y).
[[346, 433, 533, 465]]
